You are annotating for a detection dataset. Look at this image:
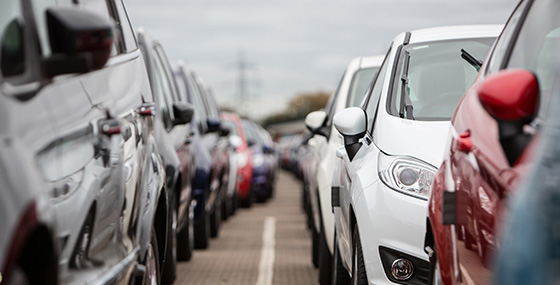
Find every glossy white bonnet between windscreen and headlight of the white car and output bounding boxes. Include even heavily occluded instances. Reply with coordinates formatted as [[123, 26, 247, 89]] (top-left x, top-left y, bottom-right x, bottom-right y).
[[373, 116, 451, 168]]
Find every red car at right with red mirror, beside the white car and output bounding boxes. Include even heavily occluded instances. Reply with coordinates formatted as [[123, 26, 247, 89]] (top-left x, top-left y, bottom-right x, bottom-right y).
[[426, 1, 560, 284]]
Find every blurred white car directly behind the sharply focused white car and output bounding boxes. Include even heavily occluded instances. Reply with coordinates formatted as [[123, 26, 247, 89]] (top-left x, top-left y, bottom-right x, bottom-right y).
[[304, 56, 383, 285]]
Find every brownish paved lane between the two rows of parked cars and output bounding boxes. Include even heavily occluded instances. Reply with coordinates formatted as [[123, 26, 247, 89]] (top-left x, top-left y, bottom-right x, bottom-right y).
[[175, 170, 318, 285]]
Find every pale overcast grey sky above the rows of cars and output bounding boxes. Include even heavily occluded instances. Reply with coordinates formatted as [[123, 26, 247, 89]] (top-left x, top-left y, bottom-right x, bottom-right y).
[[125, 0, 518, 120]]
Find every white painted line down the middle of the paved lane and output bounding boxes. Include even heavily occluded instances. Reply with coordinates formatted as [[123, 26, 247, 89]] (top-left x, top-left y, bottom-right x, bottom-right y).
[[256, 217, 276, 285]]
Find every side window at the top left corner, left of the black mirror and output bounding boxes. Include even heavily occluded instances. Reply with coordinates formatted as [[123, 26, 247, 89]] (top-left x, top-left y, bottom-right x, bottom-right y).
[[0, 0, 25, 77]]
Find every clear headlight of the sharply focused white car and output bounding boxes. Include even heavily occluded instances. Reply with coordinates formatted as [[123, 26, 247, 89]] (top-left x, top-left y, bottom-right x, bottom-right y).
[[378, 152, 437, 200]]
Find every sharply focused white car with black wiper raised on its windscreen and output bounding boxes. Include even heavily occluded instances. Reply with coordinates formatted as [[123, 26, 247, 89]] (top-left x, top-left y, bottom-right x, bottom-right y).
[[332, 25, 501, 284]]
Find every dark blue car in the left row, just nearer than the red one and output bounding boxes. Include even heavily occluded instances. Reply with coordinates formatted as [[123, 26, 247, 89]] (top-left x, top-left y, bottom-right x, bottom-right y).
[[174, 62, 229, 248]]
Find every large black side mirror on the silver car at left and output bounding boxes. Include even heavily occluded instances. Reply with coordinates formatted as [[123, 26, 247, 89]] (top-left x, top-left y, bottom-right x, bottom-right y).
[[43, 7, 114, 77]]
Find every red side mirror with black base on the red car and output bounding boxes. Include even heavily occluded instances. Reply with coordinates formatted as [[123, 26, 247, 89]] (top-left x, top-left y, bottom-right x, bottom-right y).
[[478, 69, 540, 165]]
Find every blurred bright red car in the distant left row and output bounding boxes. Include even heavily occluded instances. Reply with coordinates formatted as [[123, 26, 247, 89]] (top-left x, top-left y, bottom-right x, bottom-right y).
[[222, 113, 253, 209]]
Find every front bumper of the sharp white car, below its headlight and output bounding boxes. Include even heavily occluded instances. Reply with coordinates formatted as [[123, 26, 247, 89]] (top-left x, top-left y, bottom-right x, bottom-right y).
[[355, 180, 429, 284]]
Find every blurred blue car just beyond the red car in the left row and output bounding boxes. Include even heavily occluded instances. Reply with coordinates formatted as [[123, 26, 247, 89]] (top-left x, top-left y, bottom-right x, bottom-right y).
[[242, 119, 277, 203]]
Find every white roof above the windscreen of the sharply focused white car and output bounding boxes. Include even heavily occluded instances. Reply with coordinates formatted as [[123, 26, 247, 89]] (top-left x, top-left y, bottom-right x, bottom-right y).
[[394, 25, 504, 44]]
